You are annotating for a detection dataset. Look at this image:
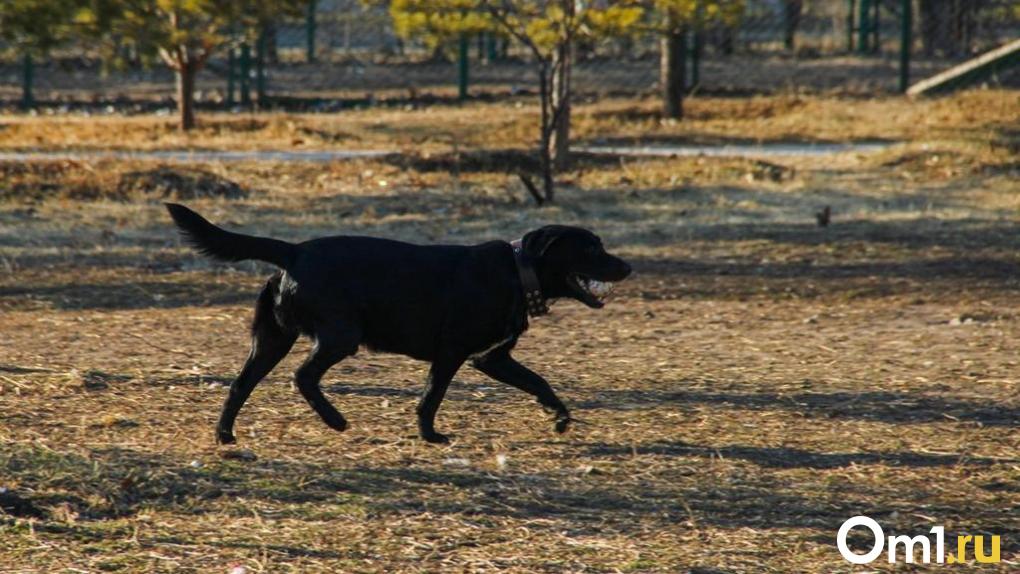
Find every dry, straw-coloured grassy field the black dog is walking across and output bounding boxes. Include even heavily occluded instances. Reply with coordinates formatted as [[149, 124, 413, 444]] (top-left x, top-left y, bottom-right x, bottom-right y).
[[0, 91, 1020, 574]]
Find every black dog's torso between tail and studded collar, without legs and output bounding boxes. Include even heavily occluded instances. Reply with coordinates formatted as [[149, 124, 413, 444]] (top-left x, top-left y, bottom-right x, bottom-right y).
[[283, 237, 513, 360]]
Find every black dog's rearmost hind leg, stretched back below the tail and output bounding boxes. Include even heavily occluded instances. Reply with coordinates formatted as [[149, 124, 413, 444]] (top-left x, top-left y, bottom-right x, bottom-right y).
[[216, 276, 298, 445]]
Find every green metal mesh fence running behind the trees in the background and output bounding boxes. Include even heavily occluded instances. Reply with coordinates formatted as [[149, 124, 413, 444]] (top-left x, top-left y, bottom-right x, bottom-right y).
[[0, 0, 1020, 111]]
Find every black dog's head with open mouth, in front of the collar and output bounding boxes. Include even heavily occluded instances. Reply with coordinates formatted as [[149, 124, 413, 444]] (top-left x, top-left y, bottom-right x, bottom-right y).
[[521, 225, 630, 309]]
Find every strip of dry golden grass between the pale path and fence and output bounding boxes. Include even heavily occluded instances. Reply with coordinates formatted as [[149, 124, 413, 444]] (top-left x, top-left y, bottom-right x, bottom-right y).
[[0, 90, 1020, 153]]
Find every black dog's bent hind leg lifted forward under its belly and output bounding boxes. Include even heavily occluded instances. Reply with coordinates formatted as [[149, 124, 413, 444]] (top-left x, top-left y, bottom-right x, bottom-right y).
[[294, 327, 361, 432]]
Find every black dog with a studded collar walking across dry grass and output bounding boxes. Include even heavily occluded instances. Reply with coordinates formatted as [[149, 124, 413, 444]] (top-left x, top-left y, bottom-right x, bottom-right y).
[[166, 204, 630, 443]]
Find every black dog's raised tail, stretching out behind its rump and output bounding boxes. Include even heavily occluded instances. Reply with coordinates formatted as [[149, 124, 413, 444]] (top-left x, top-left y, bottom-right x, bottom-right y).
[[166, 203, 298, 269]]
